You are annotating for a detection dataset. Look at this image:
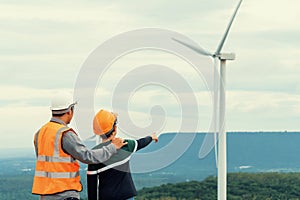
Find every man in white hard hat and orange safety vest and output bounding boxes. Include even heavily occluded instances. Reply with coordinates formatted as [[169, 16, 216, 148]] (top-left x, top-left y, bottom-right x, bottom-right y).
[[32, 93, 126, 200]]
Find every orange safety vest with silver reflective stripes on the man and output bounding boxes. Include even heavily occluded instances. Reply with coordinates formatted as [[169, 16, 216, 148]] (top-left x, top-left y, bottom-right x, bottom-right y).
[[32, 122, 82, 195]]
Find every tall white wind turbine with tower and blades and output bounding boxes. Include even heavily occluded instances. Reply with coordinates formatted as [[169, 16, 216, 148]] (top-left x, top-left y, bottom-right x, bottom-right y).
[[173, 0, 242, 200]]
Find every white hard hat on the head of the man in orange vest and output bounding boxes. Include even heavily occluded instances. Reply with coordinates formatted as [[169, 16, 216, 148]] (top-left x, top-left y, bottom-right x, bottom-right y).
[[50, 92, 77, 114]]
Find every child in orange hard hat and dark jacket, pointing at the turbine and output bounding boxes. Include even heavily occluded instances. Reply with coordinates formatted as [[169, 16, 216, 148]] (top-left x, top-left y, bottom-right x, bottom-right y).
[[87, 110, 158, 200]]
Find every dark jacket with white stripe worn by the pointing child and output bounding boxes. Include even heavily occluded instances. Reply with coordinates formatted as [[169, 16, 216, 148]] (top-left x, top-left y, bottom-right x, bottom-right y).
[[87, 136, 152, 200]]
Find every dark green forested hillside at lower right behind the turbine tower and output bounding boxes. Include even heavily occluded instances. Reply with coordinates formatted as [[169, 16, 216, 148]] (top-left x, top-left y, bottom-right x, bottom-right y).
[[136, 173, 300, 200]]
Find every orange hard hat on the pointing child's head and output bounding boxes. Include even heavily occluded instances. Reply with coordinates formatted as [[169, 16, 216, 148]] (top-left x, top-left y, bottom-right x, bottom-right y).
[[93, 110, 117, 135]]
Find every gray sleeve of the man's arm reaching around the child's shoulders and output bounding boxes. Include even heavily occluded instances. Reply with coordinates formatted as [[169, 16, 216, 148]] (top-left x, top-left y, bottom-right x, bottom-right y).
[[62, 131, 117, 164]]
